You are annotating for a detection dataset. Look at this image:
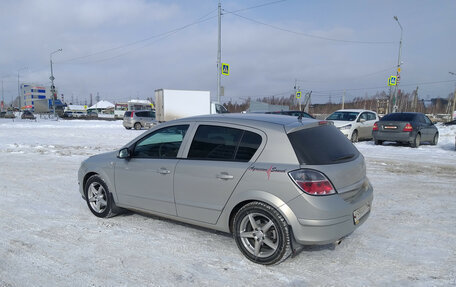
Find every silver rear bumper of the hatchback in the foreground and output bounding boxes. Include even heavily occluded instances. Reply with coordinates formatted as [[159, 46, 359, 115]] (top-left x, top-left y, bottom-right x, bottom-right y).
[[281, 180, 374, 245]]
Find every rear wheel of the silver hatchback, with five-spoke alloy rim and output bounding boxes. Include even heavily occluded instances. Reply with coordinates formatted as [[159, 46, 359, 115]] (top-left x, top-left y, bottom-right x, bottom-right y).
[[232, 201, 291, 265]]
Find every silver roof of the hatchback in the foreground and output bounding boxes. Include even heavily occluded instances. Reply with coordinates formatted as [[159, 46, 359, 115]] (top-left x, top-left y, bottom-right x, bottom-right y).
[[168, 113, 321, 132]]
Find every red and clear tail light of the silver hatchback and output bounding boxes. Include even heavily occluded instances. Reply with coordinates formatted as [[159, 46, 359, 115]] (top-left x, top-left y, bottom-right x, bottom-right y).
[[288, 169, 336, 195]]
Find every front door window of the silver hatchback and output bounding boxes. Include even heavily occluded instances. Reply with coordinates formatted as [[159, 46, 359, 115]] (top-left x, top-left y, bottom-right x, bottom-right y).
[[132, 125, 188, 158]]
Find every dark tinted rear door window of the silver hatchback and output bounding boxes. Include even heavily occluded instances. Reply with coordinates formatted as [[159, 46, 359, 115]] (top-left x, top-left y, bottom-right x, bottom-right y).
[[187, 125, 261, 162]]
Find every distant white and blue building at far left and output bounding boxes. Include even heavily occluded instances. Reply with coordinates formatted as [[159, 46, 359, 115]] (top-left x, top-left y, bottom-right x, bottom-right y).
[[21, 83, 63, 113]]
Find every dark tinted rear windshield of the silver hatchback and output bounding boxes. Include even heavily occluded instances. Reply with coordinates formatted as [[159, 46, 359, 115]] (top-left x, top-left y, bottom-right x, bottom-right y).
[[288, 125, 359, 165]]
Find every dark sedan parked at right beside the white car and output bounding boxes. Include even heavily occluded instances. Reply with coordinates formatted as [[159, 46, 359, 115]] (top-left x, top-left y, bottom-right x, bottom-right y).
[[372, 113, 439, 147]]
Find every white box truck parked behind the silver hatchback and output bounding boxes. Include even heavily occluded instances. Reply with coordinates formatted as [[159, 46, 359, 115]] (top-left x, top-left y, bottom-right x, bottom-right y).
[[155, 89, 228, 122]]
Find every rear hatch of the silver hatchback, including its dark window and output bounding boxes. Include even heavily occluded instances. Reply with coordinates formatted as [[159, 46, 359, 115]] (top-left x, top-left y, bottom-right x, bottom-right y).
[[288, 122, 369, 201]]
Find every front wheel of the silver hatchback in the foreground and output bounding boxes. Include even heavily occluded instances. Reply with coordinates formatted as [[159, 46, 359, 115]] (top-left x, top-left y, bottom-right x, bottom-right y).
[[84, 175, 119, 218]]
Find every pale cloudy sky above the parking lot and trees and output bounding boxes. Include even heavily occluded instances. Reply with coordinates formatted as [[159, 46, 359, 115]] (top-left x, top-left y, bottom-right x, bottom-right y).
[[0, 0, 456, 106]]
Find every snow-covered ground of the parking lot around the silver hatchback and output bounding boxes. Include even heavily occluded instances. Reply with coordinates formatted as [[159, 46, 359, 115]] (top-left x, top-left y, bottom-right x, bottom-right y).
[[0, 119, 456, 286]]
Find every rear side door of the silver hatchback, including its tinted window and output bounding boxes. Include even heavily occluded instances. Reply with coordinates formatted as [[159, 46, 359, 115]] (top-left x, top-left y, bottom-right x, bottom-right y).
[[174, 124, 265, 224]]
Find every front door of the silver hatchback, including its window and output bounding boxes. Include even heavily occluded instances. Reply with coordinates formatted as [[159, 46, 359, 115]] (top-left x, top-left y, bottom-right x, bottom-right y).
[[115, 125, 188, 215]]
